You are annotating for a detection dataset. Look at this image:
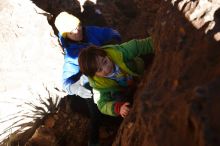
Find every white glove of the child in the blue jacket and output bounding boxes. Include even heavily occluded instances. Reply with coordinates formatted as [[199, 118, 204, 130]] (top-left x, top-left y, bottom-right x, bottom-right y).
[[70, 77, 92, 98]]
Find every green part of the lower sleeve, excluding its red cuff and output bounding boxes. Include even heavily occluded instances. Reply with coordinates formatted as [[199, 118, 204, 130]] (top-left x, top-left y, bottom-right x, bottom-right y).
[[93, 88, 117, 116]]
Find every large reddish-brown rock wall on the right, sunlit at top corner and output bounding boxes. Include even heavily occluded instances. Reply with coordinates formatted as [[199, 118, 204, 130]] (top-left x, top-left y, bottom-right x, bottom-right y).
[[113, 0, 220, 146]]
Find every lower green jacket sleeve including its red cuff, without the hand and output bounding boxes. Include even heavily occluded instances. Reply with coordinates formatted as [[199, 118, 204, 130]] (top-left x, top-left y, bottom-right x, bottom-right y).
[[93, 88, 126, 116]]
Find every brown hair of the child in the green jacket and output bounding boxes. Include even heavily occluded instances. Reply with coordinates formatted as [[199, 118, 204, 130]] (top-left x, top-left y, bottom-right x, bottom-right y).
[[78, 45, 107, 77]]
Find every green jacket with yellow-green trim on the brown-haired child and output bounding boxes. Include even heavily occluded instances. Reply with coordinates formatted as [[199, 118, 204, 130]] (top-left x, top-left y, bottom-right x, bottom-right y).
[[89, 37, 154, 116]]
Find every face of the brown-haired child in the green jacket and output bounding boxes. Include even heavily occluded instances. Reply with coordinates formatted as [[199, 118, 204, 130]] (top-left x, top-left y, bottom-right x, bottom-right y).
[[95, 56, 114, 77]]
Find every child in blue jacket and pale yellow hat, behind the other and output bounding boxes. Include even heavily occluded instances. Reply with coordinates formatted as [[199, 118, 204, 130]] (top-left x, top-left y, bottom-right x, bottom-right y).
[[55, 12, 121, 146]]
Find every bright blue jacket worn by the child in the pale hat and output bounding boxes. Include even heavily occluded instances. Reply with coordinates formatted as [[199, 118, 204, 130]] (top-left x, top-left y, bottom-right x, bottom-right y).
[[59, 26, 121, 95]]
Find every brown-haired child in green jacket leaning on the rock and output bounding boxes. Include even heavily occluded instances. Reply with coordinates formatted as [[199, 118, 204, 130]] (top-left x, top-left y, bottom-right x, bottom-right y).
[[79, 37, 154, 117]]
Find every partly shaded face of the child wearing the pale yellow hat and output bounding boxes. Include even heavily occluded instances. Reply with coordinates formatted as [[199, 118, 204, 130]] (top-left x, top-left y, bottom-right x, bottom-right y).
[[66, 26, 83, 41]]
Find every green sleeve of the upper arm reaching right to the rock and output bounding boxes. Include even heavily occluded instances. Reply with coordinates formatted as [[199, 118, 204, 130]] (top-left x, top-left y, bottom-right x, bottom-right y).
[[114, 37, 154, 60]]
